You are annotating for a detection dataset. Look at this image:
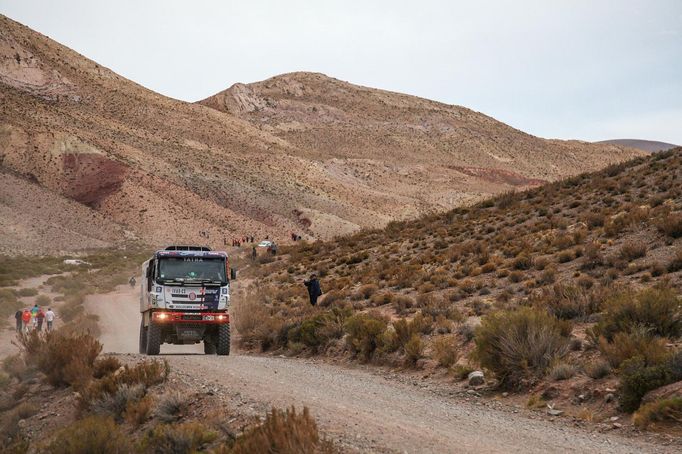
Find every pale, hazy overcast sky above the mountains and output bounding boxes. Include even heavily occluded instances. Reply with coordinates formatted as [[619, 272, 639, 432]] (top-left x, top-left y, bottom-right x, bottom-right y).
[[0, 0, 682, 144]]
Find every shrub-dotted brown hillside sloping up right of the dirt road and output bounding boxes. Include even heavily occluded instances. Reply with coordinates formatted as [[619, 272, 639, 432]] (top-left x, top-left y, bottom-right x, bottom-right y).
[[236, 148, 682, 421]]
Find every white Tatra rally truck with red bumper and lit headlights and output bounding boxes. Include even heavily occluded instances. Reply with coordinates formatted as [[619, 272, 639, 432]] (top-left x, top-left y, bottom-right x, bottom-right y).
[[140, 246, 236, 355]]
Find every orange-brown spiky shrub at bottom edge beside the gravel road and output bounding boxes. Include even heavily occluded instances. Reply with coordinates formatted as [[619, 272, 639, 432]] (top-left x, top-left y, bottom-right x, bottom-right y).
[[229, 407, 335, 454]]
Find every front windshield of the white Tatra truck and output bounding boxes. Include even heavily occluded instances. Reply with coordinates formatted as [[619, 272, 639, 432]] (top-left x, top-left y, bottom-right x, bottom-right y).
[[158, 257, 227, 283]]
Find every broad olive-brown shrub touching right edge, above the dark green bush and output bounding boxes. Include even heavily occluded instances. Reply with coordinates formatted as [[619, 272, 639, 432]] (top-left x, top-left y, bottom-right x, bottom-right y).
[[595, 287, 682, 341]]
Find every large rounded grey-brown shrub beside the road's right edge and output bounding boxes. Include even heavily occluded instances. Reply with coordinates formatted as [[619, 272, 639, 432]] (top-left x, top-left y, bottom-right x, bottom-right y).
[[474, 307, 570, 386]]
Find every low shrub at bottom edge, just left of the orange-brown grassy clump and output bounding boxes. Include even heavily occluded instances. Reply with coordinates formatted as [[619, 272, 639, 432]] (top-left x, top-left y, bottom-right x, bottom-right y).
[[139, 422, 218, 454]]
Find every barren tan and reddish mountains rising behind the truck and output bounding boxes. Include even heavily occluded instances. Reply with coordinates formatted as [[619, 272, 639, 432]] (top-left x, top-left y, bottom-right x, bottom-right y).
[[0, 17, 639, 252]]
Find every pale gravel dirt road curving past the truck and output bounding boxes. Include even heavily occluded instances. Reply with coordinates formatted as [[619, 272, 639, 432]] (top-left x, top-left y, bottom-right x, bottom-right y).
[[82, 286, 679, 453]]
